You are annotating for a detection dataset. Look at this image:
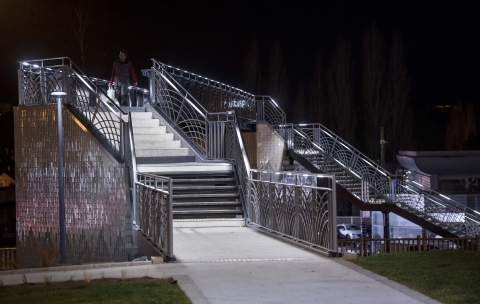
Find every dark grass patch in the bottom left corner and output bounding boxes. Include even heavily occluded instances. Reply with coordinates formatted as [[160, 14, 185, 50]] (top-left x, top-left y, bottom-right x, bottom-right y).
[[0, 281, 191, 304]]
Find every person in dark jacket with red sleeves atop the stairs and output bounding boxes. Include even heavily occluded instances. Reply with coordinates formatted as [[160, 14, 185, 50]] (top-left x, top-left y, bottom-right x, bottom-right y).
[[109, 50, 138, 106]]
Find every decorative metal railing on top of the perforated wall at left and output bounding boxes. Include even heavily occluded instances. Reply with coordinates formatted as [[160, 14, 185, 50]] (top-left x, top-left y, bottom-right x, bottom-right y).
[[18, 57, 126, 158]]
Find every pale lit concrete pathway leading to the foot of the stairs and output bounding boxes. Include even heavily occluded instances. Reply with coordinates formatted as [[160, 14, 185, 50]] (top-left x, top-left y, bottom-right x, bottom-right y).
[[0, 227, 438, 304]]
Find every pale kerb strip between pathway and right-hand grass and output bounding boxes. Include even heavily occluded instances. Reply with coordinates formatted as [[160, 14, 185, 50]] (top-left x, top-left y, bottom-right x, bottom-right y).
[[332, 258, 441, 304]]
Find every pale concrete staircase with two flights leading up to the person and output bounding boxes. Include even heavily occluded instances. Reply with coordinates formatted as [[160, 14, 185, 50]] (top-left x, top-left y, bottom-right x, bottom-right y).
[[131, 112, 245, 227]]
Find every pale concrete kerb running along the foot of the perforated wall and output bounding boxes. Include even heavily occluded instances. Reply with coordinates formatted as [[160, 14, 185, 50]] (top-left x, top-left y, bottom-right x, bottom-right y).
[[0, 261, 152, 275]]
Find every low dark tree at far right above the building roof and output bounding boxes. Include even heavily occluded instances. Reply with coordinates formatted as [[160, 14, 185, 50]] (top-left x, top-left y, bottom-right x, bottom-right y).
[[445, 102, 476, 150]]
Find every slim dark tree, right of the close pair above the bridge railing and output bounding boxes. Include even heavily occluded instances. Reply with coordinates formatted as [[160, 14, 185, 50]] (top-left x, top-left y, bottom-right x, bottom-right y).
[[266, 41, 288, 106]]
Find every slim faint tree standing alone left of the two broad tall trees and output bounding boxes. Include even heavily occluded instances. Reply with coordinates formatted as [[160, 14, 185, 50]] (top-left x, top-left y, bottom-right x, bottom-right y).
[[307, 52, 328, 125]]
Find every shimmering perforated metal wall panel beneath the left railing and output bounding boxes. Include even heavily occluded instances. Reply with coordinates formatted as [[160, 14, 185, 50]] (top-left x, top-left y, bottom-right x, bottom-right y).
[[14, 105, 133, 268]]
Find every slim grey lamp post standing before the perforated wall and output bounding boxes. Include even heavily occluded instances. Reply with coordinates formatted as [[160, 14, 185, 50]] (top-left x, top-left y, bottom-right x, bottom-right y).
[[52, 92, 67, 264]]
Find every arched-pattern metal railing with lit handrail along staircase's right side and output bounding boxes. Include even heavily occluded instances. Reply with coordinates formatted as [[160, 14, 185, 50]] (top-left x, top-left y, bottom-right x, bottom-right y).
[[150, 61, 250, 217]]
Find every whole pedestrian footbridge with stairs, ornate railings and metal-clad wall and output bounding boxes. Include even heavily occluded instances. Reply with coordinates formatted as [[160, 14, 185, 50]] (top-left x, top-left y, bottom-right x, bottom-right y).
[[14, 57, 480, 266]]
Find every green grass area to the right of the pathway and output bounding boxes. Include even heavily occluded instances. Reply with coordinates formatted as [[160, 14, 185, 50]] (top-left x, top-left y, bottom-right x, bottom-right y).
[[354, 250, 480, 304]]
